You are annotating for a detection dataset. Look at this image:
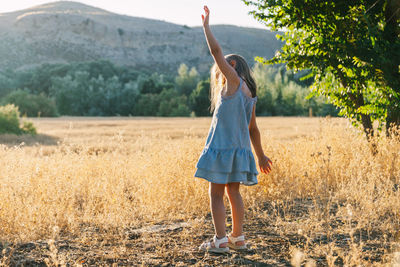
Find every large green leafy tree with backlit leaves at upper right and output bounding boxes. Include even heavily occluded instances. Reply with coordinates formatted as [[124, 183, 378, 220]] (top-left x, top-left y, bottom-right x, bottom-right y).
[[243, 0, 400, 136]]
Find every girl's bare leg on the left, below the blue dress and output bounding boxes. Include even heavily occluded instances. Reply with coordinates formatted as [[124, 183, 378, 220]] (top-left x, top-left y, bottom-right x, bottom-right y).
[[209, 183, 228, 248]]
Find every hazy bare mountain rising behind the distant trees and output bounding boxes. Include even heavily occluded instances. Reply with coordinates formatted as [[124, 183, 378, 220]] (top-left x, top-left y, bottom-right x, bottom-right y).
[[0, 1, 282, 74]]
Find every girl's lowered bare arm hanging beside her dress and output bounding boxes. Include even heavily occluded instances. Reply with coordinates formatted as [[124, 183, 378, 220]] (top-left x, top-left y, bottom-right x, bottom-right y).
[[249, 104, 272, 174]]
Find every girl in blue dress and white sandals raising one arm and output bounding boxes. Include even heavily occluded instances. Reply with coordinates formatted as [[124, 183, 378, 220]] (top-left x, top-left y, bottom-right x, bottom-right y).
[[194, 6, 272, 253]]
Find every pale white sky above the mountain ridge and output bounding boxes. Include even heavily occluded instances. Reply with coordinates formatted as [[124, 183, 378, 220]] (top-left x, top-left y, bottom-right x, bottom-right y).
[[0, 0, 265, 29]]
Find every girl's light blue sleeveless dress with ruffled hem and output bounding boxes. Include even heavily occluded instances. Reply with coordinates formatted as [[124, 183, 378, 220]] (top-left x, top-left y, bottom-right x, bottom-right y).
[[194, 79, 258, 185]]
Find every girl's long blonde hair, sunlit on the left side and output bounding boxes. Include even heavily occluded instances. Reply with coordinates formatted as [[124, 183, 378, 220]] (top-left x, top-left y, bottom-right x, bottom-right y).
[[209, 54, 257, 112]]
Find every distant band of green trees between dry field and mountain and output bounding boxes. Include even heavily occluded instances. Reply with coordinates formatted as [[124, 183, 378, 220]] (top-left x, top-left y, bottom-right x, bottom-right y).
[[0, 61, 337, 117]]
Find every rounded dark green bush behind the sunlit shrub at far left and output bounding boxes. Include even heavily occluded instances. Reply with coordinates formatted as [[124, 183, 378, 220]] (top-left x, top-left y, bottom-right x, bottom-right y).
[[2, 90, 57, 117]]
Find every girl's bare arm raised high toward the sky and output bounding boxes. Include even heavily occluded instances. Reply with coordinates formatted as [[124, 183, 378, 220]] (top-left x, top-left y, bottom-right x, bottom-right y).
[[201, 6, 240, 89]]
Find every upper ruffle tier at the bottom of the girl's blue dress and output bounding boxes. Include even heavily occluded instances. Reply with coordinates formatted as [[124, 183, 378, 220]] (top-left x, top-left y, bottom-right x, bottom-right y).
[[196, 147, 258, 175]]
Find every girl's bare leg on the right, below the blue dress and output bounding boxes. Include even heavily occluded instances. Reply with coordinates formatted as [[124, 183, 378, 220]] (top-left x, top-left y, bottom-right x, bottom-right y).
[[226, 183, 244, 246]]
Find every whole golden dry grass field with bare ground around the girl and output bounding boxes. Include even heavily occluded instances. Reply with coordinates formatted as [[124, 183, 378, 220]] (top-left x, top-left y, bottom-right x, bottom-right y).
[[0, 117, 400, 267]]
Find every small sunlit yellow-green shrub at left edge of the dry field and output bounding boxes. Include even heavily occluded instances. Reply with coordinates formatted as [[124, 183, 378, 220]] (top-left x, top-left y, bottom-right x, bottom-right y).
[[0, 104, 36, 135]]
